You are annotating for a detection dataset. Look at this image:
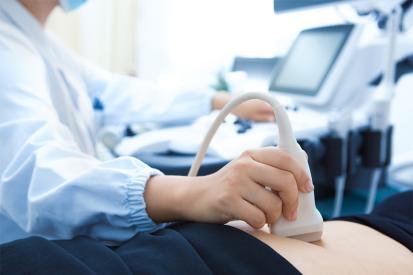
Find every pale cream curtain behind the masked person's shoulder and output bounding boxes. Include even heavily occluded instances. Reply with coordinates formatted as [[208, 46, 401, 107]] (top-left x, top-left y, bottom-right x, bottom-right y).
[[47, 0, 138, 74]]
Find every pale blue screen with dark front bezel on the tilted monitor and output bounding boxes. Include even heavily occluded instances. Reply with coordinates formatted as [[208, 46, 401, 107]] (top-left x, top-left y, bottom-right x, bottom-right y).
[[270, 25, 353, 96]]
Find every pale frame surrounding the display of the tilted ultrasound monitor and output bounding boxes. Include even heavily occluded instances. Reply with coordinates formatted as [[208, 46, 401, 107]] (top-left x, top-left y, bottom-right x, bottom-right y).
[[269, 24, 361, 105]]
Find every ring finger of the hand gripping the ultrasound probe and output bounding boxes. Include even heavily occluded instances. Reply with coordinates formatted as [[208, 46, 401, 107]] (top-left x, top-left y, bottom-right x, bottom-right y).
[[243, 183, 282, 224]]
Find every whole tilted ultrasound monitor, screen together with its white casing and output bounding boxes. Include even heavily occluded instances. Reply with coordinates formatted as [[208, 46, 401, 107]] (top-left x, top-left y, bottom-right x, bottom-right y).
[[269, 24, 360, 109]]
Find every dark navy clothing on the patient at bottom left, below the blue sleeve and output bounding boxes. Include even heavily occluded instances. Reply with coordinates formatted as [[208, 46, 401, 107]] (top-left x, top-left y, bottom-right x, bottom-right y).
[[0, 223, 299, 275]]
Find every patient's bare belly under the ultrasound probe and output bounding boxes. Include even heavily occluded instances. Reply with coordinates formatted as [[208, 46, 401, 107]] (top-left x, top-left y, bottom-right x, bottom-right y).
[[230, 221, 413, 275]]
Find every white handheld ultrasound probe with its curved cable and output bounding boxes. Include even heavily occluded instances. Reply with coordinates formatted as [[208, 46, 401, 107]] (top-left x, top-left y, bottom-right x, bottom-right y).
[[188, 93, 323, 242]]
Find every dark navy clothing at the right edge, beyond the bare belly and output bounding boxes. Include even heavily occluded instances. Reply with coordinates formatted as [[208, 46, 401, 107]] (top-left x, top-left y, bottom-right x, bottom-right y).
[[335, 191, 413, 252]]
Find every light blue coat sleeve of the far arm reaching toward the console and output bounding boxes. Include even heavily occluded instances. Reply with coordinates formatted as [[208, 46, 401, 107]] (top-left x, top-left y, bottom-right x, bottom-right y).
[[79, 54, 213, 125]]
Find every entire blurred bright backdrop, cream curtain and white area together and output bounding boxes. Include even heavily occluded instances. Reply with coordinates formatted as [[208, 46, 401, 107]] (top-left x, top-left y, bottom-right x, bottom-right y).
[[48, 0, 343, 81]]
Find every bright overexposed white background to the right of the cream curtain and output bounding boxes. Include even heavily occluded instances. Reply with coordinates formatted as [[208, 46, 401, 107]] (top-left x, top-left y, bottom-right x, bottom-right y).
[[136, 0, 342, 85]]
